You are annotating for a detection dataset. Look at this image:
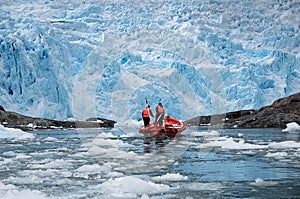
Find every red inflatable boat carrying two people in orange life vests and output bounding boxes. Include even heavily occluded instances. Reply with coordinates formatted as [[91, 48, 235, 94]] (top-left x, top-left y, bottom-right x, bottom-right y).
[[139, 116, 186, 137]]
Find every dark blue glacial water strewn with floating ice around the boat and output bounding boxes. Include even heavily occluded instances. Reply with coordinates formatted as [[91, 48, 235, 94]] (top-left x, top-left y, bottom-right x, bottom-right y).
[[0, 128, 300, 199]]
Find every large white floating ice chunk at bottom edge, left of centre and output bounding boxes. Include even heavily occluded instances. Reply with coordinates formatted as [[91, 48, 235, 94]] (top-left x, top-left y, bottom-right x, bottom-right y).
[[99, 176, 170, 197]]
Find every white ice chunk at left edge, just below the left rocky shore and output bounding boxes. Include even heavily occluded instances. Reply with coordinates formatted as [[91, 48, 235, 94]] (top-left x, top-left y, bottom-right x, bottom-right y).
[[0, 124, 34, 140]]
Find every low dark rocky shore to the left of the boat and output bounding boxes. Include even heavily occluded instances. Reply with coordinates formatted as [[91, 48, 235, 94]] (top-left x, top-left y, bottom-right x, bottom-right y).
[[0, 106, 116, 131]]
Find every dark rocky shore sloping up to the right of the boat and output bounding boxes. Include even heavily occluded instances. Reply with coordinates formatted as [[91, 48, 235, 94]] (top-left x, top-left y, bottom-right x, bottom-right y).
[[184, 93, 300, 128]]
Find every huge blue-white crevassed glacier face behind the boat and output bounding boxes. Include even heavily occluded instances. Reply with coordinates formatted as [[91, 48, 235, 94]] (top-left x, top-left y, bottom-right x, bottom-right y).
[[0, 0, 300, 123]]
